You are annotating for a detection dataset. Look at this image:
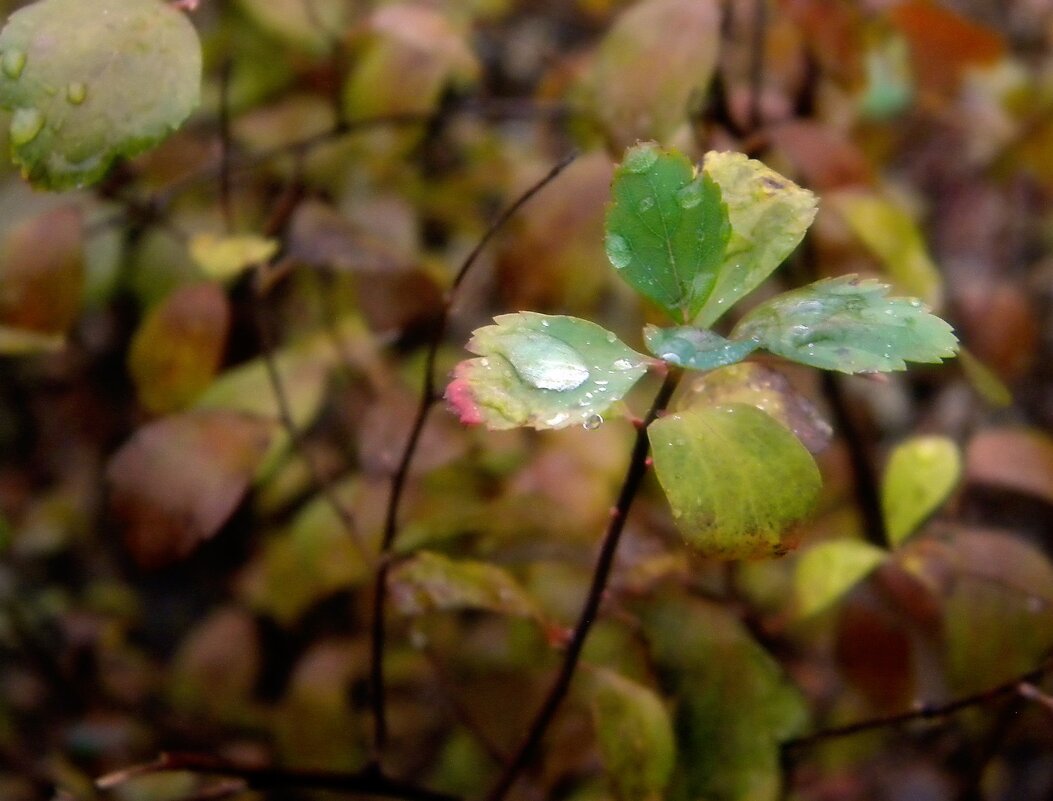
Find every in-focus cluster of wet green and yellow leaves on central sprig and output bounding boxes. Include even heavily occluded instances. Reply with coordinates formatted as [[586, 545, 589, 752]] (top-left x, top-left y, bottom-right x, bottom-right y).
[[446, 143, 957, 558]]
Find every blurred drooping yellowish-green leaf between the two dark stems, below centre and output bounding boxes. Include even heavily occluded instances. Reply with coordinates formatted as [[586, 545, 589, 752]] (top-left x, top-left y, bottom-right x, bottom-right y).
[[391, 550, 539, 618]]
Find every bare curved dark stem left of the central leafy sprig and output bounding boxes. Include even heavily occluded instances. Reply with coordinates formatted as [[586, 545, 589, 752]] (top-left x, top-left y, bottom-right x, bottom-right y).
[[370, 154, 576, 760]]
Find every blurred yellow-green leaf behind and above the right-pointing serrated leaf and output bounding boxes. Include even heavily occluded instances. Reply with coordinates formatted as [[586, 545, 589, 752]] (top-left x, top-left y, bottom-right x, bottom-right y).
[[823, 191, 943, 306]]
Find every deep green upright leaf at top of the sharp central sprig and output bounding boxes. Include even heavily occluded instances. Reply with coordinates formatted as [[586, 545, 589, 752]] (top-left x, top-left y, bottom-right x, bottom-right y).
[[604, 142, 730, 323]]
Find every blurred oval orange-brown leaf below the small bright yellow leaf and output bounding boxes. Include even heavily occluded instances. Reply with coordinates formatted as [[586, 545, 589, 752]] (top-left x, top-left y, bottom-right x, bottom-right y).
[[128, 283, 231, 414]]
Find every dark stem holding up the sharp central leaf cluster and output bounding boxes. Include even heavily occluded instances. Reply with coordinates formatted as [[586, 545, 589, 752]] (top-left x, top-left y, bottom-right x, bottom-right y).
[[486, 368, 682, 801]]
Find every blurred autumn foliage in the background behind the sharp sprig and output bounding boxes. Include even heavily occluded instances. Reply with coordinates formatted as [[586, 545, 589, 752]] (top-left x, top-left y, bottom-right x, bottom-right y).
[[0, 0, 1053, 801]]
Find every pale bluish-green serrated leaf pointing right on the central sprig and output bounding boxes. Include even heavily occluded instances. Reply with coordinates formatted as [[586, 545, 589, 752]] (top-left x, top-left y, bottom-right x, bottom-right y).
[[733, 276, 958, 373]]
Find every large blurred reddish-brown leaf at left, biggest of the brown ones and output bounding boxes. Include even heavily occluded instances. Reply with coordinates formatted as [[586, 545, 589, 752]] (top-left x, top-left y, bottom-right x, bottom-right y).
[[106, 410, 274, 567]]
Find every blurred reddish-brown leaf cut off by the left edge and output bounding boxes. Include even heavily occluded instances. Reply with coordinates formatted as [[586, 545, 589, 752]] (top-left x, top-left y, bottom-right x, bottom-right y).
[[0, 205, 84, 334]]
